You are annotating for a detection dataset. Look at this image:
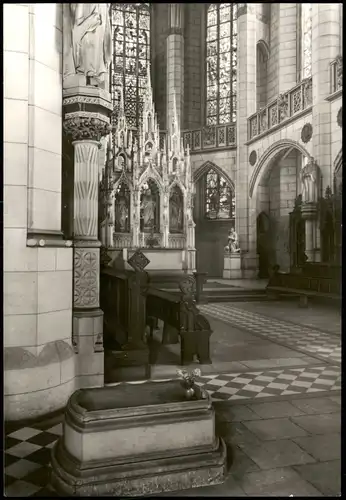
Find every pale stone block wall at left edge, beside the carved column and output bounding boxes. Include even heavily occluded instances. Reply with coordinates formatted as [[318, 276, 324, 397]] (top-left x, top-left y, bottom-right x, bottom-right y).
[[4, 4, 75, 420]]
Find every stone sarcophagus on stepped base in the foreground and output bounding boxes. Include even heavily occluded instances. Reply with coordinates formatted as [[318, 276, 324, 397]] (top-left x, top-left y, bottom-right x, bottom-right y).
[[52, 380, 226, 496]]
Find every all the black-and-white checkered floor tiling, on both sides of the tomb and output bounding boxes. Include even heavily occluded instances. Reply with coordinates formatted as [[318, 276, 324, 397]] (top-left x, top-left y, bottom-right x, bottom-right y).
[[4, 304, 341, 498]]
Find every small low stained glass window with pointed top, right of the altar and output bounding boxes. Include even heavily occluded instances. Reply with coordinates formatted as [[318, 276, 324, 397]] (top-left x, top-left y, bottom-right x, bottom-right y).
[[205, 169, 235, 219]]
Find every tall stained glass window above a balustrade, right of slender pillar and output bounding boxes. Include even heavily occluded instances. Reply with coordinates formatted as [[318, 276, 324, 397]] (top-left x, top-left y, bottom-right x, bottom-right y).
[[206, 3, 237, 125]]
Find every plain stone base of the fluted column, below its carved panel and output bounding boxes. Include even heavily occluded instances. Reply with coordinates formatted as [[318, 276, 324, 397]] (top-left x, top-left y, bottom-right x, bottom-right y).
[[72, 308, 104, 388]]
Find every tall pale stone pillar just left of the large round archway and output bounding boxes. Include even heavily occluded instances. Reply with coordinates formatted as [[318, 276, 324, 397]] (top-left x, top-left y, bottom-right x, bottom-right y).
[[236, 4, 257, 278]]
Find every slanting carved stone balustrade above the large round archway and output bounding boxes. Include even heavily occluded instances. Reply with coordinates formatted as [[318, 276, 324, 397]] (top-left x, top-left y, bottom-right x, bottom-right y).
[[248, 78, 312, 140]]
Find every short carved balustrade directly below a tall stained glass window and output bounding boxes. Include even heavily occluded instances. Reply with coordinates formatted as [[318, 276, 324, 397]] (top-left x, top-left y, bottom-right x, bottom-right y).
[[183, 123, 237, 153]]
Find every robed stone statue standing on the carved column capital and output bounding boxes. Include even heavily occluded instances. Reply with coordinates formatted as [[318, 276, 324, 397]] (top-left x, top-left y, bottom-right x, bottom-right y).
[[63, 3, 112, 87]]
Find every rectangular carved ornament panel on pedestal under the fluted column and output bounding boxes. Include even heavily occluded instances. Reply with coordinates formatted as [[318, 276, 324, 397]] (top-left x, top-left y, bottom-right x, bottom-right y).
[[74, 248, 99, 307]]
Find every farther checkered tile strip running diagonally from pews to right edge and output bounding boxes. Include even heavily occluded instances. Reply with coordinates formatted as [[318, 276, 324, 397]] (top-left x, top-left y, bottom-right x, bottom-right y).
[[198, 303, 341, 364]]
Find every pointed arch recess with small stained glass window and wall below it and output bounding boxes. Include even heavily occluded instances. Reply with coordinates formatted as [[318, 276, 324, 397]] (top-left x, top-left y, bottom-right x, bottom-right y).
[[194, 162, 235, 278]]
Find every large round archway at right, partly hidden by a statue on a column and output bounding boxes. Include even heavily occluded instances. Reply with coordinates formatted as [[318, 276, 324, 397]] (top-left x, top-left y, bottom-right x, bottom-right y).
[[249, 140, 310, 277]]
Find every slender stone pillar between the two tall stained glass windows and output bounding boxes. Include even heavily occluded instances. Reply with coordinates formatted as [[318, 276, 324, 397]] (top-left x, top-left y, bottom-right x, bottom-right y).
[[166, 3, 185, 129]]
